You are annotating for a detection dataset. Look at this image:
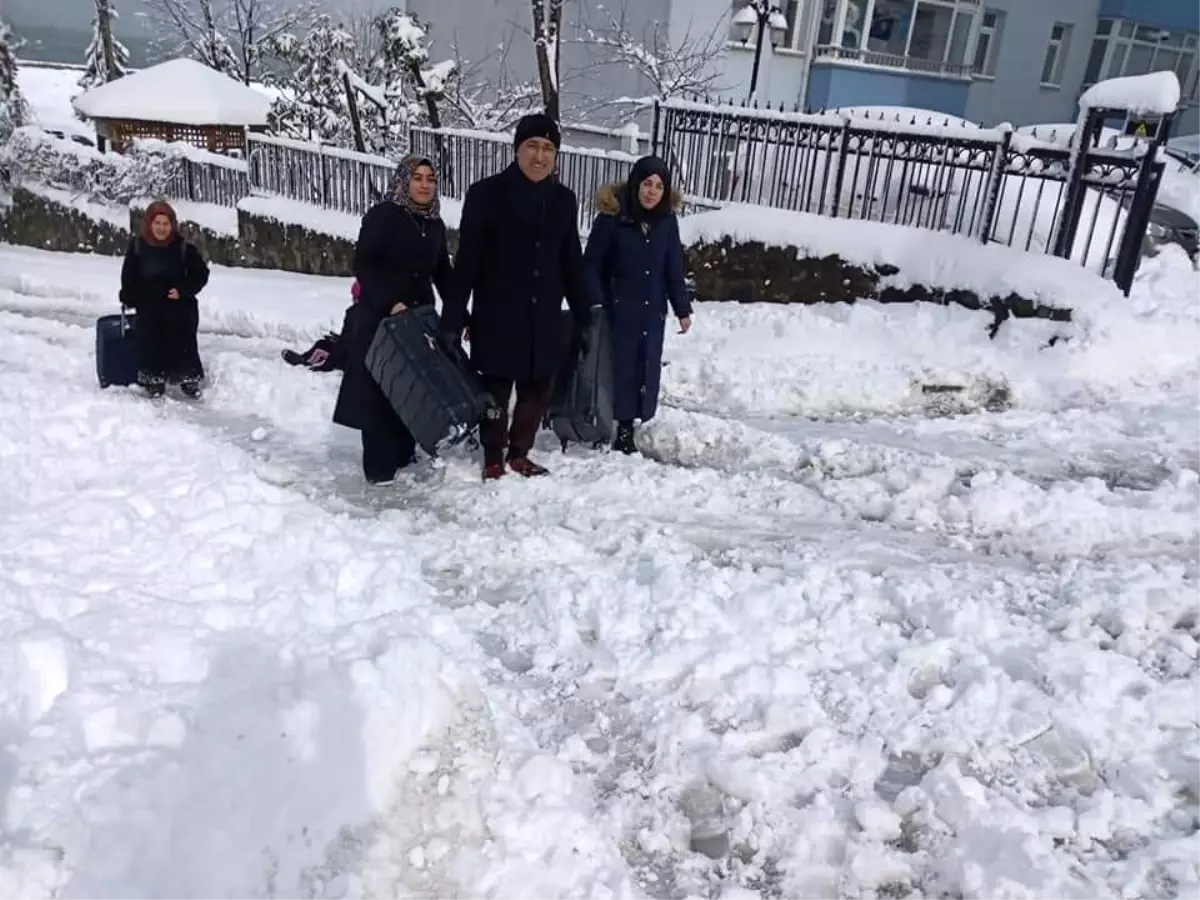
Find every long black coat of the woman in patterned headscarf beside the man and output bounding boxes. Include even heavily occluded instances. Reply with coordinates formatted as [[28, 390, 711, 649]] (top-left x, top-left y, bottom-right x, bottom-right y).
[[334, 200, 451, 431]]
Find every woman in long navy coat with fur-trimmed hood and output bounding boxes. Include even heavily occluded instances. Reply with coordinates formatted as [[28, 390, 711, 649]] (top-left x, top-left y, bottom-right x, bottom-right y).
[[583, 156, 691, 454]]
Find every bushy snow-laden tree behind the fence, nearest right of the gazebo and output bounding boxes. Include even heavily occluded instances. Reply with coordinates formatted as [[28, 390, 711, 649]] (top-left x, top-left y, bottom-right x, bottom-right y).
[[266, 16, 367, 146]]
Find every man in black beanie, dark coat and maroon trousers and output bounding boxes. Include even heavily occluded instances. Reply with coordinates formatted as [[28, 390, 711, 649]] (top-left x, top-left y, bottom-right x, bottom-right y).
[[442, 113, 590, 479]]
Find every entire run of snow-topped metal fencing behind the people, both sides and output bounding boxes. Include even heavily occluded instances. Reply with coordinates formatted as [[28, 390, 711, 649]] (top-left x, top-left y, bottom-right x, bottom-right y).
[[75, 101, 1169, 292]]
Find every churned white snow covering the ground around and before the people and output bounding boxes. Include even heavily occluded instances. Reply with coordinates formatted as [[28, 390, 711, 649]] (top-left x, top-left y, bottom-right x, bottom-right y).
[[0, 247, 1200, 900]]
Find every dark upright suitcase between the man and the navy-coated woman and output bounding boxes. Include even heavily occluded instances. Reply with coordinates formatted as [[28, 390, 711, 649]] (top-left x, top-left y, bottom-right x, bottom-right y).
[[546, 307, 614, 451]]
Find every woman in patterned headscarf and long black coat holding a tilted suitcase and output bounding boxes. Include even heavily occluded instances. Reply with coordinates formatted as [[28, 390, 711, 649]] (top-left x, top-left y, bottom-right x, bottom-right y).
[[334, 156, 451, 485]]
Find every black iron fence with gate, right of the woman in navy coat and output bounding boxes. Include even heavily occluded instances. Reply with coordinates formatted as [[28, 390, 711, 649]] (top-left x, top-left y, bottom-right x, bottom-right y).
[[654, 101, 1165, 290]]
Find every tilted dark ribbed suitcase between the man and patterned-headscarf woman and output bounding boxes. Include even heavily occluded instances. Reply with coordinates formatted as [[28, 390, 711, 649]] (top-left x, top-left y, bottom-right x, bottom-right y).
[[366, 306, 500, 456]]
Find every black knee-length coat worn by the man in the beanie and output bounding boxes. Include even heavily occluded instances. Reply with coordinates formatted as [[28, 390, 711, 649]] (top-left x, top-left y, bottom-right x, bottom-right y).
[[442, 163, 592, 382]]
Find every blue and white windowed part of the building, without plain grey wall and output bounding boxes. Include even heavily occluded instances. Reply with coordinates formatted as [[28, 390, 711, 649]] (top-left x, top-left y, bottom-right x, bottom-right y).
[[728, 0, 1200, 132]]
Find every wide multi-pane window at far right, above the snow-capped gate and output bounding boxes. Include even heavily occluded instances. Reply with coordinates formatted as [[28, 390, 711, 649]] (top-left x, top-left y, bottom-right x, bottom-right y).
[[1084, 19, 1200, 102]]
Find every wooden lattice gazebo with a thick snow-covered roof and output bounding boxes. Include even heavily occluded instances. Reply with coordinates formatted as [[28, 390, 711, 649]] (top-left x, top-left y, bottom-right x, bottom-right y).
[[72, 59, 271, 152]]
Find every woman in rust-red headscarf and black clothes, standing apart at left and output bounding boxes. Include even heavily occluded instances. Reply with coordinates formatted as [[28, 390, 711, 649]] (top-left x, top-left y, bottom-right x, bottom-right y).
[[120, 200, 209, 398]]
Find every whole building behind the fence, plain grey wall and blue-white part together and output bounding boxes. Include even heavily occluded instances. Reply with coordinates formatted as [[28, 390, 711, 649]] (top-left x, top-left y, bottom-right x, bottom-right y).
[[408, 0, 1200, 133]]
